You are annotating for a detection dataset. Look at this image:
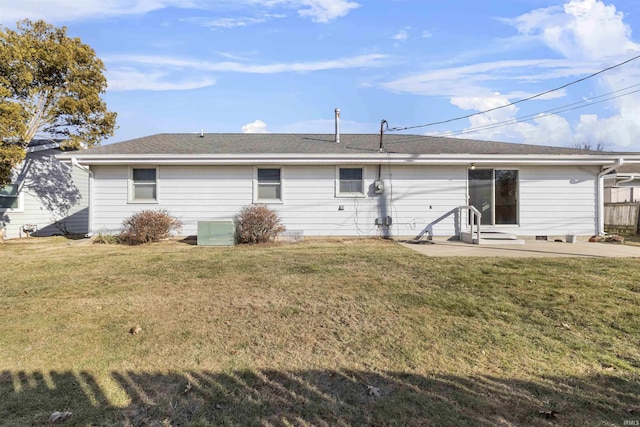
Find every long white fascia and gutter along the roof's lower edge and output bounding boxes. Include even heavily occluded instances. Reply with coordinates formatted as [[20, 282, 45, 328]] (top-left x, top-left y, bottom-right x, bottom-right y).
[[57, 152, 640, 167]]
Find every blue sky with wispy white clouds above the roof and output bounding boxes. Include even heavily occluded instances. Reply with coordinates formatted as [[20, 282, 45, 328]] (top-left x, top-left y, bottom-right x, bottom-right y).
[[0, 0, 640, 151]]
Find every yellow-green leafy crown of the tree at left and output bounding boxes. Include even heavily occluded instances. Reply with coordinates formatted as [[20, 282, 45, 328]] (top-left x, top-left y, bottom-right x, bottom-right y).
[[0, 19, 116, 185]]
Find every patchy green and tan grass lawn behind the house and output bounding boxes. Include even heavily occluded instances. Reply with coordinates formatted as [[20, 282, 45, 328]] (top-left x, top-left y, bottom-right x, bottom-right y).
[[0, 238, 640, 426]]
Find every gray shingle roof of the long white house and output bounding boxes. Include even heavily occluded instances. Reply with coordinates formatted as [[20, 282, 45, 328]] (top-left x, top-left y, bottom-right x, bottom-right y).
[[83, 133, 603, 156]]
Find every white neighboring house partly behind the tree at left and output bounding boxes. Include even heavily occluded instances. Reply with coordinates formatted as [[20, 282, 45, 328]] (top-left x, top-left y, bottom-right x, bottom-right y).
[[0, 139, 89, 238]]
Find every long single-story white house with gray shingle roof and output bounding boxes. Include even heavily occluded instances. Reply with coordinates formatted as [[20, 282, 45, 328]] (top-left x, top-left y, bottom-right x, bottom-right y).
[[59, 133, 640, 242]]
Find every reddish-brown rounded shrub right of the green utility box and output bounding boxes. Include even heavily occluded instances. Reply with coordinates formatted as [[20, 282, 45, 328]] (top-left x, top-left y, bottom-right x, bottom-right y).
[[233, 205, 286, 243]]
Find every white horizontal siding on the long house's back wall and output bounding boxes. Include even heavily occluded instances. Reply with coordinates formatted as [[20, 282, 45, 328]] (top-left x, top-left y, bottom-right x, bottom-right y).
[[87, 165, 598, 237]]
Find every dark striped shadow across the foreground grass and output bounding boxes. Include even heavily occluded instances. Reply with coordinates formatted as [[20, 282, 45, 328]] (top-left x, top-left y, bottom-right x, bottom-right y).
[[0, 370, 640, 426]]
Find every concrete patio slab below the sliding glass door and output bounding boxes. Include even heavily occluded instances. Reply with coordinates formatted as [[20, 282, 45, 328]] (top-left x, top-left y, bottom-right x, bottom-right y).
[[400, 239, 640, 258]]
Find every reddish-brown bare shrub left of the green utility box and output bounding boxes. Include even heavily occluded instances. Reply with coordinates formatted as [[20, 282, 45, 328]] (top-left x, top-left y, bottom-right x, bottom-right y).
[[119, 209, 182, 245]]
